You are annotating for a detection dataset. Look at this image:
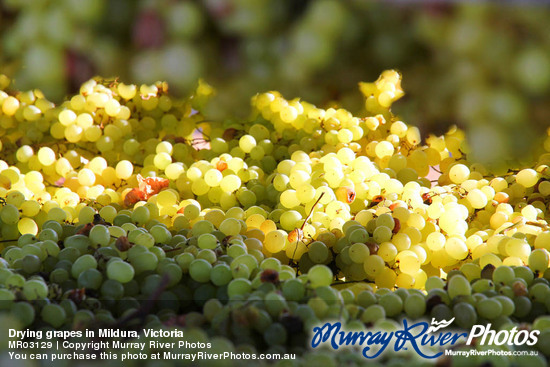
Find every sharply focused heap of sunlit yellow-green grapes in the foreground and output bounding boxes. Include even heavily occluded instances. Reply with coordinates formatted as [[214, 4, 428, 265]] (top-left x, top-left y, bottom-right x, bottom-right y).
[[0, 70, 550, 366]]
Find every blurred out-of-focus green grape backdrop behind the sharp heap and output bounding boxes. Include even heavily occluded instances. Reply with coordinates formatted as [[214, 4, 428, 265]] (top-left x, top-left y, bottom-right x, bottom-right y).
[[0, 0, 550, 161]]
